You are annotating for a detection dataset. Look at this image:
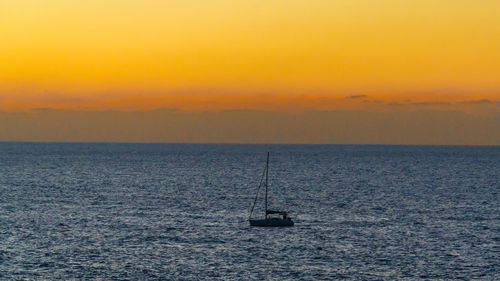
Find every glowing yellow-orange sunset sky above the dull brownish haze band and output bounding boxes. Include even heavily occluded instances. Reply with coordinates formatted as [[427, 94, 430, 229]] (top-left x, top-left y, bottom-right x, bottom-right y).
[[0, 0, 500, 144]]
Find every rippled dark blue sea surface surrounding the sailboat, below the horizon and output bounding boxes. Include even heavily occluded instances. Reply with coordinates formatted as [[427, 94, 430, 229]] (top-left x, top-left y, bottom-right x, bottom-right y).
[[0, 143, 500, 280]]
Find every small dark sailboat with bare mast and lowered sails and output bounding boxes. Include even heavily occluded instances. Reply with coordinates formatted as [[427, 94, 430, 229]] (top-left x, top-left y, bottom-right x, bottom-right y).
[[248, 151, 294, 227]]
